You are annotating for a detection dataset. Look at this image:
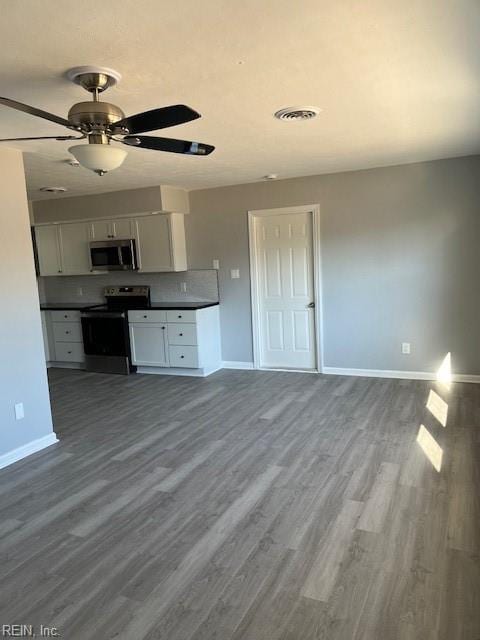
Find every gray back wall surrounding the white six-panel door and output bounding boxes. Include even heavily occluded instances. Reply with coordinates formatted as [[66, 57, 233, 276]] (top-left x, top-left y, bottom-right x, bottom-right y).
[[186, 156, 480, 374]]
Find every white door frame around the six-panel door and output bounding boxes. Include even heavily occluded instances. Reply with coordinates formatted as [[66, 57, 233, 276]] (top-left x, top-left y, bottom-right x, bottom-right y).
[[248, 204, 323, 373]]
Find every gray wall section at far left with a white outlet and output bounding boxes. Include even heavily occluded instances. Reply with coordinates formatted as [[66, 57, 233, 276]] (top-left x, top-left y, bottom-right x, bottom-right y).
[[0, 149, 52, 456]]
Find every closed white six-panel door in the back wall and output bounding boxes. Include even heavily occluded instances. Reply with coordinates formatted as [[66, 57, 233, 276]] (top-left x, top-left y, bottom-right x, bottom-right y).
[[254, 212, 317, 369]]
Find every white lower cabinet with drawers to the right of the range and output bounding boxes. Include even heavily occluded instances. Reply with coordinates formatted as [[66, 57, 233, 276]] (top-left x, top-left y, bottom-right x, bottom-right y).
[[128, 305, 221, 376]]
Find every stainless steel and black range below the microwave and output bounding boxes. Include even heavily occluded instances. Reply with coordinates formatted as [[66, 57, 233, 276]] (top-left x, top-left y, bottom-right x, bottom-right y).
[[81, 286, 150, 374]]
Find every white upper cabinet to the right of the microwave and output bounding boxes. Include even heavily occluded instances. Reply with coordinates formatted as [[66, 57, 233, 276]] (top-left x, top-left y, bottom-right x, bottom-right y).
[[135, 213, 187, 272]]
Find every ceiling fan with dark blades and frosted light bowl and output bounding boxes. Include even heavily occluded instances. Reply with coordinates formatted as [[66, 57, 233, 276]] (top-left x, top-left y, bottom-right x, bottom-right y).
[[0, 66, 215, 176]]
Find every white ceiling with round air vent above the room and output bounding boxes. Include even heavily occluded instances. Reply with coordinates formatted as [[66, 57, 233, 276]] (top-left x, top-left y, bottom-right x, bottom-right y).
[[0, 0, 480, 200]]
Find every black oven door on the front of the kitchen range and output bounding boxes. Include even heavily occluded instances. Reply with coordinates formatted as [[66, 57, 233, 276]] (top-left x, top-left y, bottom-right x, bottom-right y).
[[81, 311, 135, 373]]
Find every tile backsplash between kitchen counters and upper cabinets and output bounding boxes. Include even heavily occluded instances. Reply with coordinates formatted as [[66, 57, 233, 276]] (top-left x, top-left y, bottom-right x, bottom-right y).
[[38, 269, 219, 303]]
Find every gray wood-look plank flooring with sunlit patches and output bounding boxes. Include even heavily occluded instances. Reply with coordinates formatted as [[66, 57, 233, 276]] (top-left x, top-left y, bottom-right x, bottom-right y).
[[0, 370, 480, 640]]
